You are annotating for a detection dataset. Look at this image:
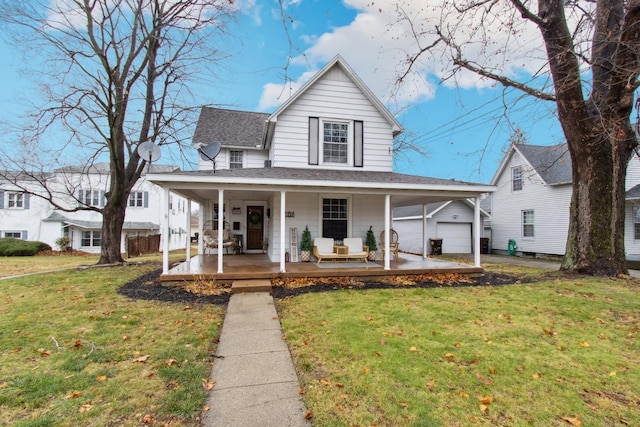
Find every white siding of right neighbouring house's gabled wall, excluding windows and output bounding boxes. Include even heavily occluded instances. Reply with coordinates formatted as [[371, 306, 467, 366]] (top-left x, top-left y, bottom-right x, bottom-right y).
[[491, 152, 572, 255]]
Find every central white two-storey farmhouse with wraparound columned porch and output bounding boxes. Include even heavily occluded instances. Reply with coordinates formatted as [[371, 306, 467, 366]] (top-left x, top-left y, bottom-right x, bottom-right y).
[[149, 56, 493, 273]]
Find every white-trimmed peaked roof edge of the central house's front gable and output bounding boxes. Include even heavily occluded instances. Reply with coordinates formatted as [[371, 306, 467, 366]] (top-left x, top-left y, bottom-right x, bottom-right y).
[[264, 55, 404, 147]]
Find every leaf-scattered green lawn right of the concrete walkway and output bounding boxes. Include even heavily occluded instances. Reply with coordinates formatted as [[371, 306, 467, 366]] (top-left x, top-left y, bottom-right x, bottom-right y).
[[279, 278, 640, 426]]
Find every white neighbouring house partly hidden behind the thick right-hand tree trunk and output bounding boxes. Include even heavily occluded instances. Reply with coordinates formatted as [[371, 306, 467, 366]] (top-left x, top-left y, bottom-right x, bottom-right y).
[[490, 144, 640, 257]]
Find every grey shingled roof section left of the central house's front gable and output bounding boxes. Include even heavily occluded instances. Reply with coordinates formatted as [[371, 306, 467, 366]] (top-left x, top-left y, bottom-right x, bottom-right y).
[[192, 107, 269, 148]]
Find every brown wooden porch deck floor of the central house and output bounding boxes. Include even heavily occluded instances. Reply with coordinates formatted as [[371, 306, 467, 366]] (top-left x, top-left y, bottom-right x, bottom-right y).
[[160, 253, 483, 282]]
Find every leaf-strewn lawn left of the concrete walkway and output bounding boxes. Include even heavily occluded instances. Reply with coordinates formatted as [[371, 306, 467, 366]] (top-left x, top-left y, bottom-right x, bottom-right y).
[[0, 257, 223, 426]]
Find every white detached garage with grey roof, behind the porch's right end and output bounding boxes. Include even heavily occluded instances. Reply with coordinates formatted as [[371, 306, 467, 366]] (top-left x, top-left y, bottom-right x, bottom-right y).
[[393, 200, 491, 254]]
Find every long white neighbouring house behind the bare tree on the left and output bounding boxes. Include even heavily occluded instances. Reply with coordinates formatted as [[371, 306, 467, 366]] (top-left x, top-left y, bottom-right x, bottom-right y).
[[0, 163, 189, 252]]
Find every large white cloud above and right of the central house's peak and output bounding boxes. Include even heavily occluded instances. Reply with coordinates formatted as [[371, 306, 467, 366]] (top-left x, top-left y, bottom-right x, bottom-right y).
[[260, 0, 546, 113]]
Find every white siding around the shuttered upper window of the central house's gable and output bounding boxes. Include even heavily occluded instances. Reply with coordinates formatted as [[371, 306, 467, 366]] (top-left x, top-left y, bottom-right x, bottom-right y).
[[270, 64, 393, 171]]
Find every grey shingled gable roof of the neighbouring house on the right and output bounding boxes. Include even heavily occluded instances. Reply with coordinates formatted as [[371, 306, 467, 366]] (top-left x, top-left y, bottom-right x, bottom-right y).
[[491, 144, 572, 185]]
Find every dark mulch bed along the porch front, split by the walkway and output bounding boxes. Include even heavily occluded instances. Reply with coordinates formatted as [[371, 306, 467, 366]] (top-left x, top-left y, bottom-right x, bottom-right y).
[[118, 270, 530, 305]]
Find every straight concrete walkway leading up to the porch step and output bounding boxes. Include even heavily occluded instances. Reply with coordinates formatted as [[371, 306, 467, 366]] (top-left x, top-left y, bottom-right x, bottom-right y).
[[202, 292, 310, 427]]
